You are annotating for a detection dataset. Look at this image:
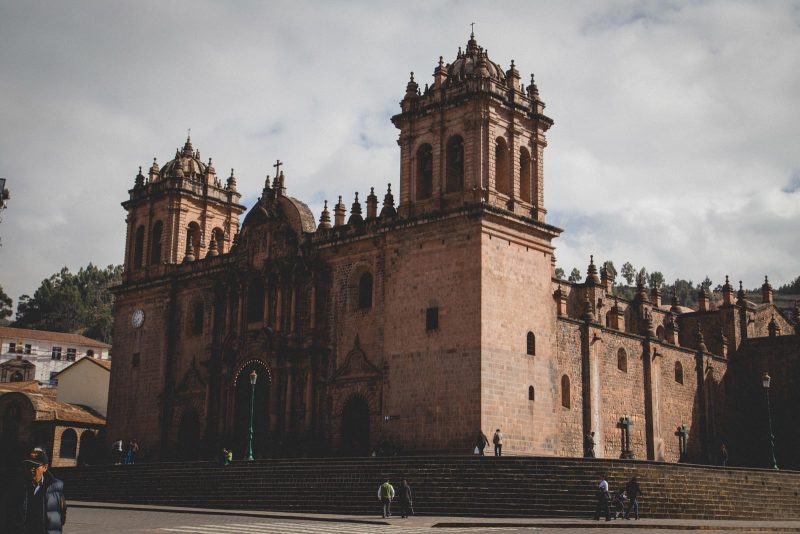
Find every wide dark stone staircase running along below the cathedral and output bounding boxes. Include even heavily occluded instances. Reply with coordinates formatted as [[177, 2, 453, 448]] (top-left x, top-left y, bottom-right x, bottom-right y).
[[54, 456, 800, 519]]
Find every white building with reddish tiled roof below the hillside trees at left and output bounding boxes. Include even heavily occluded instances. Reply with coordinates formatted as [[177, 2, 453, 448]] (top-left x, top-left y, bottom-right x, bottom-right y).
[[0, 326, 111, 385]]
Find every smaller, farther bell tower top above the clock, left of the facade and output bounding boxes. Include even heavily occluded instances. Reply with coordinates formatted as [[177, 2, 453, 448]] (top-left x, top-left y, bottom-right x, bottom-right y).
[[122, 136, 245, 280]]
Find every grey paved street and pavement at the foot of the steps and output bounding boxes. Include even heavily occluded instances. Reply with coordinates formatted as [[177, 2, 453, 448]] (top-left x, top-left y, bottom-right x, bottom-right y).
[[64, 503, 800, 534]]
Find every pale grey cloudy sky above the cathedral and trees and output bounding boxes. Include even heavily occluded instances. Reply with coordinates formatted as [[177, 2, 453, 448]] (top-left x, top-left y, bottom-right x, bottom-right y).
[[0, 0, 800, 306]]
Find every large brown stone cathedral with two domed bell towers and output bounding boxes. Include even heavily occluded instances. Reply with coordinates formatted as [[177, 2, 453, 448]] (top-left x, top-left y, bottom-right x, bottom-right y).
[[108, 34, 800, 463]]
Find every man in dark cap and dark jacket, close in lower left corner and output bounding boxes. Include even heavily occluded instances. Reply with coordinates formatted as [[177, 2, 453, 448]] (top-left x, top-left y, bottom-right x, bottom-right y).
[[0, 448, 67, 534]]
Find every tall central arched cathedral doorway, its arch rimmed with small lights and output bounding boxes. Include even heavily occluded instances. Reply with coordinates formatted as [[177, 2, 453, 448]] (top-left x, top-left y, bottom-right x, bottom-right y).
[[233, 361, 272, 460]]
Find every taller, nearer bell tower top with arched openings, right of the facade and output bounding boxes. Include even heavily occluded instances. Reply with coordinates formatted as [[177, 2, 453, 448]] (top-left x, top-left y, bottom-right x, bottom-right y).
[[392, 33, 553, 222]]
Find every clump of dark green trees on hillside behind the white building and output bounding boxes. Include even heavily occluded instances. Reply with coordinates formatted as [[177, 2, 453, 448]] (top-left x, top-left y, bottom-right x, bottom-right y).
[[14, 263, 122, 343]]
